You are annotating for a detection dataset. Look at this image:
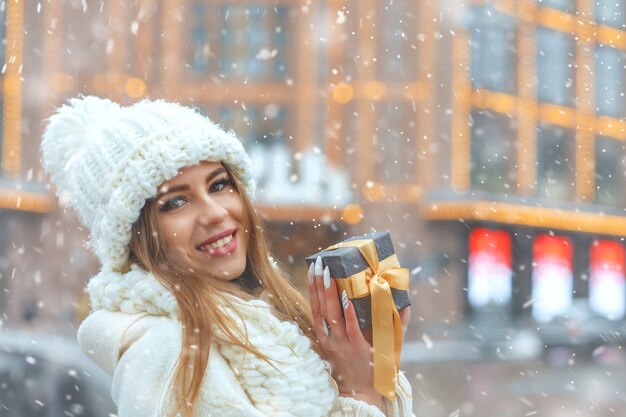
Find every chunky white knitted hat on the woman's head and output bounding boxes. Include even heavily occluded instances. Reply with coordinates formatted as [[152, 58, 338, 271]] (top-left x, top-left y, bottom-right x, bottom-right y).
[[41, 96, 255, 271]]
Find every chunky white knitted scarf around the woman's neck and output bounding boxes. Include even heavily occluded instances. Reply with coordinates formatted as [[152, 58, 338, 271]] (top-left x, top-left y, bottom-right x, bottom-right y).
[[88, 266, 337, 417]]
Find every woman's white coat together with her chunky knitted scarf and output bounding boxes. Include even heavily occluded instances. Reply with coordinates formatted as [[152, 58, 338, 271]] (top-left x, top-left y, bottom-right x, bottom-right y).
[[78, 268, 413, 417]]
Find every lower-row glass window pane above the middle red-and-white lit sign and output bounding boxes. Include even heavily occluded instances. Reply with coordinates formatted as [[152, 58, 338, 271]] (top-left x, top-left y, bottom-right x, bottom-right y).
[[537, 125, 575, 200]]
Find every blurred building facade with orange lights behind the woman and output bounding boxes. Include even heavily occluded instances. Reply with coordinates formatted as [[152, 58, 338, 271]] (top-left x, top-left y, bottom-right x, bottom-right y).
[[0, 0, 626, 334]]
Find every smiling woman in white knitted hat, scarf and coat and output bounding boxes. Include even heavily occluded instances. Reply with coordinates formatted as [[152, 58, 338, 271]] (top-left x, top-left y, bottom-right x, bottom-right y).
[[42, 97, 412, 417]]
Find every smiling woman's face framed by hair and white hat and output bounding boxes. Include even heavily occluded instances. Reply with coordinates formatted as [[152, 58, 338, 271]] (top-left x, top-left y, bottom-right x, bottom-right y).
[[156, 162, 248, 281]]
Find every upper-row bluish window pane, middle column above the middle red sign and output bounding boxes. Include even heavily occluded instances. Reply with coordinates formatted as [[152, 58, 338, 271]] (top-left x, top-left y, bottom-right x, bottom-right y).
[[537, 28, 575, 106]]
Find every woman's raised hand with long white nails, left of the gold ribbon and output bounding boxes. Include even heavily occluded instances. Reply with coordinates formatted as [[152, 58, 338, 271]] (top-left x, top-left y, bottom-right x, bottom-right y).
[[308, 258, 382, 408]]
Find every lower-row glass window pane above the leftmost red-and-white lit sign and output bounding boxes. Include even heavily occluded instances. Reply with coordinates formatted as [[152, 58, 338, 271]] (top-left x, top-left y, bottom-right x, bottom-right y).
[[471, 111, 516, 194]]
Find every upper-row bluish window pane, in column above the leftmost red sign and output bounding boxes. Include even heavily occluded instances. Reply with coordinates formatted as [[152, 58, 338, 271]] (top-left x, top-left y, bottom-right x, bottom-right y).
[[471, 7, 517, 93]]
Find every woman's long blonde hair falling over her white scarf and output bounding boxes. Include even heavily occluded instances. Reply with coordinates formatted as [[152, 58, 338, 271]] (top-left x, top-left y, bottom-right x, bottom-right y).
[[130, 166, 321, 417]]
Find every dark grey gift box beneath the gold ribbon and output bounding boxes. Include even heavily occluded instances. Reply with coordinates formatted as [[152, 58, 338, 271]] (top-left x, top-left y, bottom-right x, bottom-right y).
[[306, 232, 411, 328]]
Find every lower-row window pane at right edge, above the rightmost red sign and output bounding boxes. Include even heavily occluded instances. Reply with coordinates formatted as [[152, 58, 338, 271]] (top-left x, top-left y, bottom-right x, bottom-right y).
[[596, 137, 626, 207]]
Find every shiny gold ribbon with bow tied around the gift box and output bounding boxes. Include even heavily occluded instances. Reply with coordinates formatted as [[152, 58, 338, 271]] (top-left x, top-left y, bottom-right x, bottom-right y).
[[325, 239, 409, 401]]
